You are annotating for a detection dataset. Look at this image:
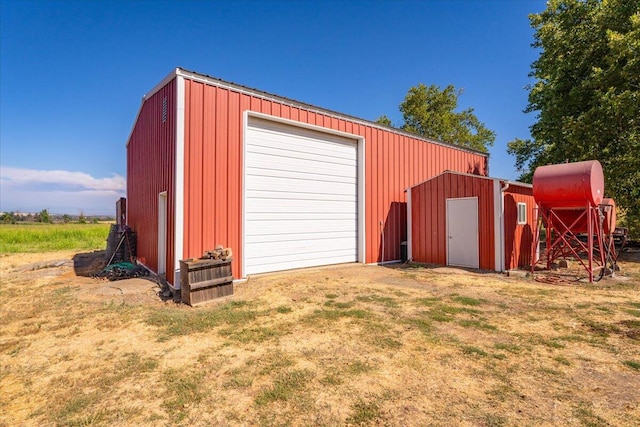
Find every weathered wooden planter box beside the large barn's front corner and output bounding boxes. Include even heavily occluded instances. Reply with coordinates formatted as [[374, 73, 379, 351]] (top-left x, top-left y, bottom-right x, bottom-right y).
[[180, 258, 233, 306]]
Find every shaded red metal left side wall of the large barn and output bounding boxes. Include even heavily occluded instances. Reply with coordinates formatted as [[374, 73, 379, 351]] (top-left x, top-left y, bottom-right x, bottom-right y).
[[127, 79, 176, 281]]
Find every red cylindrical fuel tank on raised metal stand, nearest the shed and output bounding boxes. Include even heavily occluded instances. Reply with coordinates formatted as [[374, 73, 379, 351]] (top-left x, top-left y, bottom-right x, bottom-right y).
[[533, 160, 604, 208]]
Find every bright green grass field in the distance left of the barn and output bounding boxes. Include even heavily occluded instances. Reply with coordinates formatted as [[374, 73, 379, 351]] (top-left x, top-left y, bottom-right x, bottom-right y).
[[0, 223, 110, 253]]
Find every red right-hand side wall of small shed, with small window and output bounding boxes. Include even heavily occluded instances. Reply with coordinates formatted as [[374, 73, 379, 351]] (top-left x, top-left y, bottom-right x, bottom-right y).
[[504, 184, 536, 270]]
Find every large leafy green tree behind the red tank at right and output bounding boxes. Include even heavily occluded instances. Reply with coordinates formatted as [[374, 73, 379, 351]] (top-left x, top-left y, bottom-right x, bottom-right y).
[[508, 0, 640, 232]]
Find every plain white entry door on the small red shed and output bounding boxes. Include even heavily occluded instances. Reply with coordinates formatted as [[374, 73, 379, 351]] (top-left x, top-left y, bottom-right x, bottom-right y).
[[447, 197, 480, 268]]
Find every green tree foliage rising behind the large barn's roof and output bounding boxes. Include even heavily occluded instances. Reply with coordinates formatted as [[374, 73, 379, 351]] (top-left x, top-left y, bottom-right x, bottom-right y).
[[377, 83, 496, 153]]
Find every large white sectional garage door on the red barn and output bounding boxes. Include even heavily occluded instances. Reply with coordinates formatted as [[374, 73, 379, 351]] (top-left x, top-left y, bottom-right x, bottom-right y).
[[244, 117, 358, 275]]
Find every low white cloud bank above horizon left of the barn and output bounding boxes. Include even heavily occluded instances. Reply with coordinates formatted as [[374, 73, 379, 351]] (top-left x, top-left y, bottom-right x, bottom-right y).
[[0, 166, 126, 215]]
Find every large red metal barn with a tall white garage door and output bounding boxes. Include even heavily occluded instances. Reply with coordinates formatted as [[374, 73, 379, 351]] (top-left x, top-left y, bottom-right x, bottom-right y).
[[127, 68, 488, 287]]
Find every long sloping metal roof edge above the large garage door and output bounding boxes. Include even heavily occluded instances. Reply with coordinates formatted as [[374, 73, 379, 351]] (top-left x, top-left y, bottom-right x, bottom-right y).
[[172, 67, 489, 158]]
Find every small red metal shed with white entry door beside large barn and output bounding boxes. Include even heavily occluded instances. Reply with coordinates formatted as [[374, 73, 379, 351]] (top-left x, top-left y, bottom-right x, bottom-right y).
[[407, 171, 536, 271]]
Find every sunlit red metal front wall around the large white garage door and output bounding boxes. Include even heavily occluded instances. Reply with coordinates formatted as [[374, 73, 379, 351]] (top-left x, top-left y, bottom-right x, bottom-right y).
[[183, 79, 487, 277]]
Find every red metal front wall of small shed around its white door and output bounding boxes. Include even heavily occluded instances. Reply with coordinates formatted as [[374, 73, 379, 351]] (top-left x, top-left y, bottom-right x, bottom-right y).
[[410, 173, 495, 270]]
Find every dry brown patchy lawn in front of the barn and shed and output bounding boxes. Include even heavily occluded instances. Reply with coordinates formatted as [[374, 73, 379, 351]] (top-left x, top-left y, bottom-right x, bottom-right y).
[[0, 252, 640, 426]]
